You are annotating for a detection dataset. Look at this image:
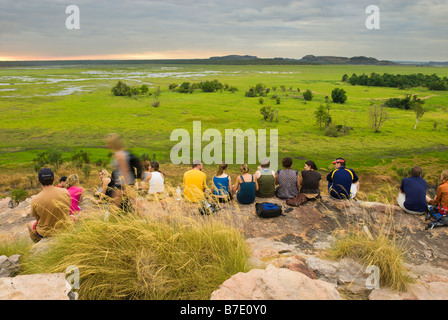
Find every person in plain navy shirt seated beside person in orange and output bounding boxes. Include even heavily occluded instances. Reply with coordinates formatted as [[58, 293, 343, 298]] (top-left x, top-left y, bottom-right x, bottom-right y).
[[397, 166, 428, 214]]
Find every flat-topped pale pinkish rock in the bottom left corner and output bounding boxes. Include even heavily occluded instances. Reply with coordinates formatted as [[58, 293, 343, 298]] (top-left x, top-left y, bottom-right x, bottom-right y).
[[0, 273, 71, 300]]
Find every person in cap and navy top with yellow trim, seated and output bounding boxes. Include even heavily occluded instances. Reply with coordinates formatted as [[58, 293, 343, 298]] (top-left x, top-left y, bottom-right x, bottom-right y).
[[327, 158, 359, 200]]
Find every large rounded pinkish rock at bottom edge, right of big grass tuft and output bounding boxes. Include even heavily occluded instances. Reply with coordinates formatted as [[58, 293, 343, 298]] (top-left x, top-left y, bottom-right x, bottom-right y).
[[211, 265, 342, 300]]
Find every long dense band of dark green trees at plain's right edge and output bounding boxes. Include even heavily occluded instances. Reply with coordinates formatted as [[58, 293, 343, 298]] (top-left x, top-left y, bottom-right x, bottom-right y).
[[342, 72, 448, 90]]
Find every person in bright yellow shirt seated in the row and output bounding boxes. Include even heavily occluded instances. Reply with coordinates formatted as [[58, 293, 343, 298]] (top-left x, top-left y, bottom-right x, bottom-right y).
[[183, 161, 207, 202]]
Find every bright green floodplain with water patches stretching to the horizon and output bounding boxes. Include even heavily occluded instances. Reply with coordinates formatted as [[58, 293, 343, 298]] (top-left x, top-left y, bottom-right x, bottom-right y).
[[0, 64, 448, 191]]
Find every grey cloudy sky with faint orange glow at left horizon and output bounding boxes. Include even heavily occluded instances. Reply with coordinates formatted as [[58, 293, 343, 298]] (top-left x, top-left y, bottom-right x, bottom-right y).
[[0, 0, 448, 61]]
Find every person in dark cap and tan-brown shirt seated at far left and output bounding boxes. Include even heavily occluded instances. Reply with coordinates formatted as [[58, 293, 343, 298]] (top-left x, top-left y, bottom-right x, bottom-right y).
[[28, 168, 71, 242]]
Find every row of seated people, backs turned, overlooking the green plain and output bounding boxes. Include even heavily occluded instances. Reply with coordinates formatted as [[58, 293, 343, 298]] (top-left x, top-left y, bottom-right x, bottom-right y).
[[28, 157, 448, 242]]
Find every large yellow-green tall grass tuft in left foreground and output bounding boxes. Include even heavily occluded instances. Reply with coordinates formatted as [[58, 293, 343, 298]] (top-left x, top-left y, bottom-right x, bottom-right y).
[[23, 208, 248, 300]]
